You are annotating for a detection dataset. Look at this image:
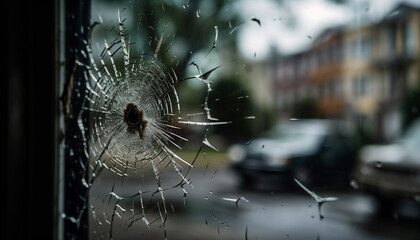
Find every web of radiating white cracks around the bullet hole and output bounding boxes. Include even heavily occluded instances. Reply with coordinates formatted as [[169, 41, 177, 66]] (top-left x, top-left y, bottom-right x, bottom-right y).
[[75, 7, 235, 239]]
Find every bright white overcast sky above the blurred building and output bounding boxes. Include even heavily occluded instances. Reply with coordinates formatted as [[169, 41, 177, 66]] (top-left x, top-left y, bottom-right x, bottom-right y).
[[235, 0, 420, 60]]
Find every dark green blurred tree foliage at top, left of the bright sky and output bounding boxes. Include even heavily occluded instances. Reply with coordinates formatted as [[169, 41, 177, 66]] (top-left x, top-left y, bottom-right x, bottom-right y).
[[131, 0, 237, 73]]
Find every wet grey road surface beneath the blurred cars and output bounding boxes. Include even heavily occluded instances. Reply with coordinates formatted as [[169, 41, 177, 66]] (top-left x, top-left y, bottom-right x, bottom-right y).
[[90, 168, 420, 240]]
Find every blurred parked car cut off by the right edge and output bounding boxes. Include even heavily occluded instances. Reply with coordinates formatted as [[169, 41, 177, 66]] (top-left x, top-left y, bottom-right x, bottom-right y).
[[355, 119, 420, 210]]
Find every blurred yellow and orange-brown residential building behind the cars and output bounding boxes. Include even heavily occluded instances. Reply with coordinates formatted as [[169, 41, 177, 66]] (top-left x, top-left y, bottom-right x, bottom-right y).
[[273, 4, 420, 141]]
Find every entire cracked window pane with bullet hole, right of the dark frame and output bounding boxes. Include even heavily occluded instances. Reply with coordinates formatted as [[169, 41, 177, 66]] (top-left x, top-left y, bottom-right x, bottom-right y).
[[60, 0, 420, 239]]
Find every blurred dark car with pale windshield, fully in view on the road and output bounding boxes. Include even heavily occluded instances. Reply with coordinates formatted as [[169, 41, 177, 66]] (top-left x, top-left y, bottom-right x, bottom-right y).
[[229, 120, 357, 187]]
